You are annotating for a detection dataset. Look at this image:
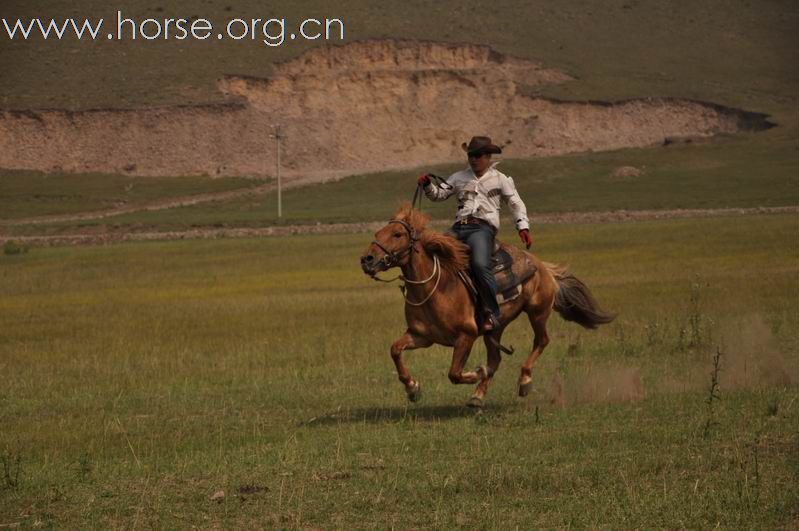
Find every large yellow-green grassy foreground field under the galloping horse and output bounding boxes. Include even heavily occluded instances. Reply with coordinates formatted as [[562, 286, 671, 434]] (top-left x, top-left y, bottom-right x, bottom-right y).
[[0, 212, 799, 529]]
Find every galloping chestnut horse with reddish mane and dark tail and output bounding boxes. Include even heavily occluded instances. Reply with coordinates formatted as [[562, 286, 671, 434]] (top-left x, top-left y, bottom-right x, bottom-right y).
[[361, 204, 615, 407]]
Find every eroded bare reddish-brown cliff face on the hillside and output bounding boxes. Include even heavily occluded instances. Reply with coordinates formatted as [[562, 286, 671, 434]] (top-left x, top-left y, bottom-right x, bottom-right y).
[[0, 40, 770, 180]]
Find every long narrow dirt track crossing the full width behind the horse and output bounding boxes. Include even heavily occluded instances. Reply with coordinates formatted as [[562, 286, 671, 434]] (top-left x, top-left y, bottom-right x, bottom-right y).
[[0, 206, 799, 247]]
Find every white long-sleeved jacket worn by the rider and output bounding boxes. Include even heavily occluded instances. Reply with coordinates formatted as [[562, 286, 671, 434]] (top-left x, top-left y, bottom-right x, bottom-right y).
[[424, 163, 530, 230]]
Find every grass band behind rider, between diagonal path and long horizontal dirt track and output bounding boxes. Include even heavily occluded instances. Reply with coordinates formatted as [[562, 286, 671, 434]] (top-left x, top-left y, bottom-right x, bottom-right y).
[[7, 136, 799, 235]]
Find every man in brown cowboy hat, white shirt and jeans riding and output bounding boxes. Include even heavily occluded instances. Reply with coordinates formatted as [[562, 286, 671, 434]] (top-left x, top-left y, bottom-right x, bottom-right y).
[[418, 136, 533, 332]]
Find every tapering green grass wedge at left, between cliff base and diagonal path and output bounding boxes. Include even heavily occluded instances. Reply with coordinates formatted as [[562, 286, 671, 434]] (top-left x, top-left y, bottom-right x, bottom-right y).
[[0, 170, 263, 220]]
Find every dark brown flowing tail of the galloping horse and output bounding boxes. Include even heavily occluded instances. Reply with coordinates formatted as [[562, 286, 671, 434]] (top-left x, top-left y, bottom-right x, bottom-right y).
[[544, 263, 616, 328]]
